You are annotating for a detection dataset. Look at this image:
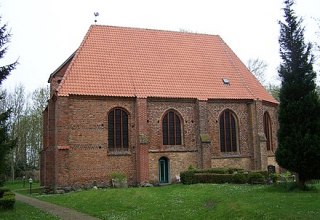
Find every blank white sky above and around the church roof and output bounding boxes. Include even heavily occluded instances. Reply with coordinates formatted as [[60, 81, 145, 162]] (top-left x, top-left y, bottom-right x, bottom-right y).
[[0, 0, 320, 91]]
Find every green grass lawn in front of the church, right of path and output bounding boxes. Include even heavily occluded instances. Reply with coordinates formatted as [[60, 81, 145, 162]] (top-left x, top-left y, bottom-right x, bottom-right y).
[[32, 184, 320, 219]]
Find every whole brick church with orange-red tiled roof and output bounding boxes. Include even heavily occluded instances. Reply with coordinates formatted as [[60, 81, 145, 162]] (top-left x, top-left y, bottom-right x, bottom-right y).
[[41, 25, 278, 188]]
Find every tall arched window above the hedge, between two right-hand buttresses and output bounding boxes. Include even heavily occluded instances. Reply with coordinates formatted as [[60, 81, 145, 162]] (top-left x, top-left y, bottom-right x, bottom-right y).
[[219, 110, 238, 152]]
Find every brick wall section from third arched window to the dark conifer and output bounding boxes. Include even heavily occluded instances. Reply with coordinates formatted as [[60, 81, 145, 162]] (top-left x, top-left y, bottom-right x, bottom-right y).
[[208, 101, 278, 169]]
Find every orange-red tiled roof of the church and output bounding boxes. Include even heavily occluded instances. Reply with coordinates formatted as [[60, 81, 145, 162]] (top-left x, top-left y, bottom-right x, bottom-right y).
[[57, 25, 277, 103]]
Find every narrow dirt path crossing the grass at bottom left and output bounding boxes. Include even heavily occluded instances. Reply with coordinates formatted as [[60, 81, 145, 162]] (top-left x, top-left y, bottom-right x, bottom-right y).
[[15, 193, 97, 220]]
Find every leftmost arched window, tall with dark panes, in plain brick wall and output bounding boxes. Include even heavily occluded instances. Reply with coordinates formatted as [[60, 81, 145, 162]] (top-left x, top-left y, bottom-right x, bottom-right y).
[[108, 108, 129, 149]]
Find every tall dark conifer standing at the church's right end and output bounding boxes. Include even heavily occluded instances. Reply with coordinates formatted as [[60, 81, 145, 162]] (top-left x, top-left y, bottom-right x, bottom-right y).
[[276, 0, 320, 188]]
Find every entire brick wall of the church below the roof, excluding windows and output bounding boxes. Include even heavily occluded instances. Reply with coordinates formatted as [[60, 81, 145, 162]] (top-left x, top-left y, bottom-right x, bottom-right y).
[[43, 96, 277, 186]]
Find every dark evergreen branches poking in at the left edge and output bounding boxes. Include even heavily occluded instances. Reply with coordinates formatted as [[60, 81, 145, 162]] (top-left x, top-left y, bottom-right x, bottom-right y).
[[0, 17, 17, 185]]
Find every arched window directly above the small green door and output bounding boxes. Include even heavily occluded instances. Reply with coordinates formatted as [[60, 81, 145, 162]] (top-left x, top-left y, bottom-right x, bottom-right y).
[[162, 111, 181, 145]]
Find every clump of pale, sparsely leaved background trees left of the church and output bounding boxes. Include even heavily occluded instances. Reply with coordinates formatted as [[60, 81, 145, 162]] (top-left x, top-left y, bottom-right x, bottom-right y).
[[0, 84, 49, 180]]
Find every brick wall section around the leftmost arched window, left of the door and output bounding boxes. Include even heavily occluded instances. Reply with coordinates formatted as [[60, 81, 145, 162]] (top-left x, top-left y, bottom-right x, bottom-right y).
[[57, 96, 137, 186]]
